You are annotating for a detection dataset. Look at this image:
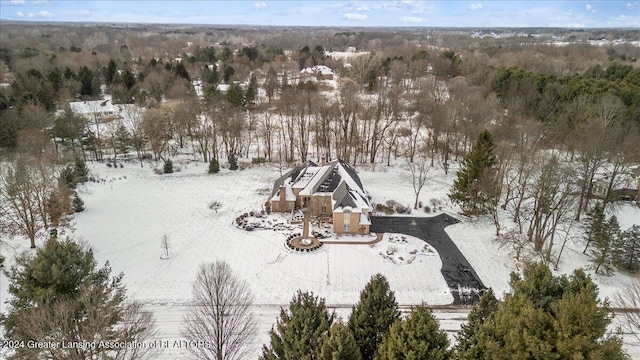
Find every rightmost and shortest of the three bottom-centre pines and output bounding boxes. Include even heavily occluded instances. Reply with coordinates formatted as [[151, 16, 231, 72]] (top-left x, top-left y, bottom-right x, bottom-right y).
[[376, 306, 452, 360]]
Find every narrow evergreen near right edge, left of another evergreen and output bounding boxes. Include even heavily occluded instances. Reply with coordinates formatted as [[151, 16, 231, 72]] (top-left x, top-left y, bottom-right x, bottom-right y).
[[590, 215, 620, 274]]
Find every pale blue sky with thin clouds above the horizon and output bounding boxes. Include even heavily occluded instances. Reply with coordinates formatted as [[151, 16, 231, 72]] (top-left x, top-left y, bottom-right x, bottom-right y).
[[0, 0, 640, 28]]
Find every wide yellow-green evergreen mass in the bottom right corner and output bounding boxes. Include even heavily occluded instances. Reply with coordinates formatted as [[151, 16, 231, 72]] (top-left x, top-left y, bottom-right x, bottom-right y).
[[459, 263, 626, 360]]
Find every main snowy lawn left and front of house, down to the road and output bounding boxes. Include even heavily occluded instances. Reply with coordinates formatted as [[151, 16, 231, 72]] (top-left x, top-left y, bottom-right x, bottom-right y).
[[69, 163, 452, 305]]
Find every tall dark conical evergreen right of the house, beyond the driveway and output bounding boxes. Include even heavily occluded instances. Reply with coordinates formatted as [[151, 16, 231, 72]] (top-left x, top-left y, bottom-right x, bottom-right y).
[[449, 130, 500, 215]]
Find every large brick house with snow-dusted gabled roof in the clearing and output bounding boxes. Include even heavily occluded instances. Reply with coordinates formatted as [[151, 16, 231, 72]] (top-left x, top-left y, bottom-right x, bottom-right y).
[[269, 159, 372, 234]]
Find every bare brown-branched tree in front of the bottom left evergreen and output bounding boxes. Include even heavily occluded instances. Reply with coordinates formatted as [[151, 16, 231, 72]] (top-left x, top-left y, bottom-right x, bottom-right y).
[[15, 285, 157, 360]]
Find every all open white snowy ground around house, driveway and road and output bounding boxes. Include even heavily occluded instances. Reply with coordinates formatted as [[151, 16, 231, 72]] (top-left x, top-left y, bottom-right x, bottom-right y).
[[0, 158, 640, 358]]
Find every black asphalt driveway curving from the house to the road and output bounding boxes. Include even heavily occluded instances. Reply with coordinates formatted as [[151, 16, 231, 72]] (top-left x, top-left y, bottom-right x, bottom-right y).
[[371, 214, 486, 305]]
